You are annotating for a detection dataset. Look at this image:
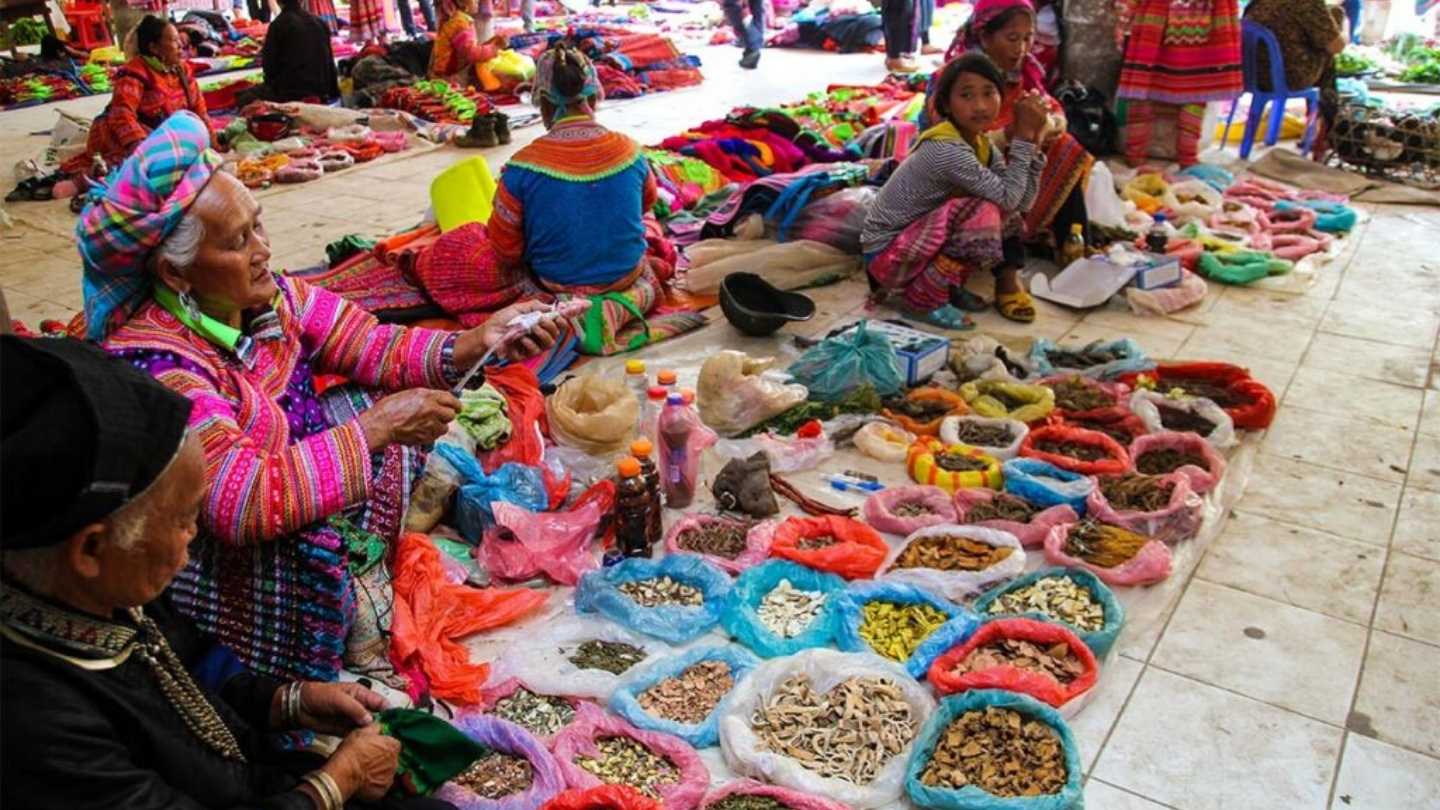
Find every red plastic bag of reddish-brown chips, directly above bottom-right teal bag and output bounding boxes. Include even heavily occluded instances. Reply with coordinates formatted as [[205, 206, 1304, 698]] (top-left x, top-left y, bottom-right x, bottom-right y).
[[929, 618, 1100, 709]]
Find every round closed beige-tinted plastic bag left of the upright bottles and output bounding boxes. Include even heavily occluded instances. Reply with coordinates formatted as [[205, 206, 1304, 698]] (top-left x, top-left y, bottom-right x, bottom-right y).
[[546, 375, 639, 455]]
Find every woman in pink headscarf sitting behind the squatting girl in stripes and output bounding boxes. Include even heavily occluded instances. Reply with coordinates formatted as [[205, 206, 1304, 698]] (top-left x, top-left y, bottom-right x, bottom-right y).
[[927, 0, 1094, 255]]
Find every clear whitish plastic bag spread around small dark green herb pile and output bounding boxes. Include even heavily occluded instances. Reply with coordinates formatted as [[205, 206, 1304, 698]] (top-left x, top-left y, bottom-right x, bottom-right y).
[[492, 615, 672, 702]]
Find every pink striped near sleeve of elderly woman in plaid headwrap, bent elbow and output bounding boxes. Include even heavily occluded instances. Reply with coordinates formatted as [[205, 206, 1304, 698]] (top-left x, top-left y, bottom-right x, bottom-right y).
[[153, 363, 372, 545]]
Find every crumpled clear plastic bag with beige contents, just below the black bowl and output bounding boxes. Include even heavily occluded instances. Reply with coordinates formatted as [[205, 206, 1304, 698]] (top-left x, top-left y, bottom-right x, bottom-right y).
[[696, 350, 809, 435]]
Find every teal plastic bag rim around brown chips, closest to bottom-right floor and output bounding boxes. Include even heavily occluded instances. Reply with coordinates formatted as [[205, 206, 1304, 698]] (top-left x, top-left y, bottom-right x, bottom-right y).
[[904, 689, 1084, 810]]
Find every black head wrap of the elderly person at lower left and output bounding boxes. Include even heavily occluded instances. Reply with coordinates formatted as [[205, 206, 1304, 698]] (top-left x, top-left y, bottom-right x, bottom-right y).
[[0, 334, 190, 549]]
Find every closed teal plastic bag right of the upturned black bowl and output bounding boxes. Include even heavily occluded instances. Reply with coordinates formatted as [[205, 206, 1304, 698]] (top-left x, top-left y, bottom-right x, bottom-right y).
[[788, 321, 904, 402]]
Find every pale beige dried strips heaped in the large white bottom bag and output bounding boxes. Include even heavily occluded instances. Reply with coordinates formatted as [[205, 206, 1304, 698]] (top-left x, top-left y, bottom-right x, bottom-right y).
[[750, 675, 919, 785]]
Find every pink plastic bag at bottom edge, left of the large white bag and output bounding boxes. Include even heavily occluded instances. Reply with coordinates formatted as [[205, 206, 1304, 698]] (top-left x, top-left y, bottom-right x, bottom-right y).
[[554, 703, 710, 810]]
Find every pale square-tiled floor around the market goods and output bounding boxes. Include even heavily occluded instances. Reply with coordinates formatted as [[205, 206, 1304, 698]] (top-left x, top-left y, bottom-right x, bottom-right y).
[[0, 49, 1440, 810]]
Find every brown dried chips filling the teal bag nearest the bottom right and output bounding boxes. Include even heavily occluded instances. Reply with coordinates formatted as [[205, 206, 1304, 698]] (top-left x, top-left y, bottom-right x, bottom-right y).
[[920, 708, 1067, 798]]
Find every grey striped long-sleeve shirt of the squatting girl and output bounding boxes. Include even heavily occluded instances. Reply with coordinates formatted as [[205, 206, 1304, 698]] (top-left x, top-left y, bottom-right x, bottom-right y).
[[860, 140, 1045, 255]]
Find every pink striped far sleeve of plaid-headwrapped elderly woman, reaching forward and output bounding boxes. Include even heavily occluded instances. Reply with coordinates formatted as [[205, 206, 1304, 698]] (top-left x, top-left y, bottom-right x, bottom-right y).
[[282, 278, 455, 391]]
